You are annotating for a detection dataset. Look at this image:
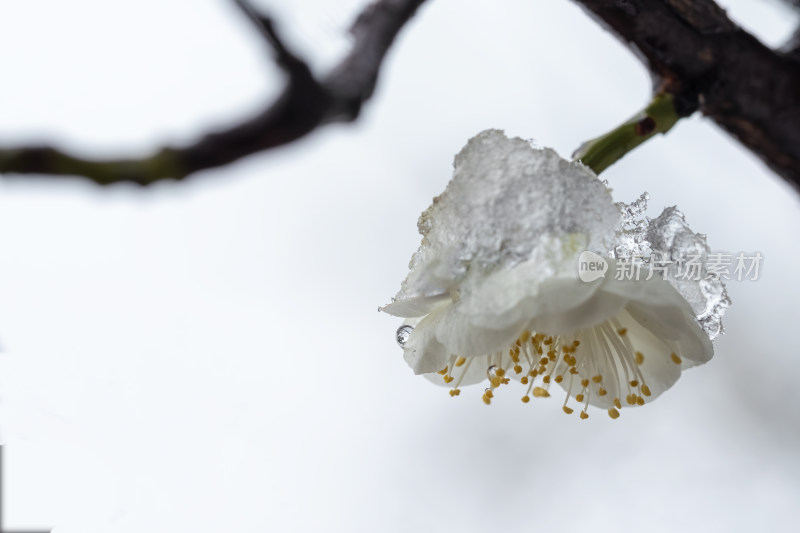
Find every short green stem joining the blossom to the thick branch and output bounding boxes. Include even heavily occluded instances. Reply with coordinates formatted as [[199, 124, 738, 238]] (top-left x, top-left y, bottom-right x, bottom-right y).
[[572, 93, 681, 174]]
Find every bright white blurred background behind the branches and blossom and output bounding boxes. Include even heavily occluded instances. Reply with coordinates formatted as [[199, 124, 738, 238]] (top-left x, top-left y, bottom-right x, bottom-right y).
[[0, 0, 800, 533]]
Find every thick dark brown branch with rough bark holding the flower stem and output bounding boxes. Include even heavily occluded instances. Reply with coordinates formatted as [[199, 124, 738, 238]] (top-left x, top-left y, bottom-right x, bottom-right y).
[[575, 0, 800, 188]]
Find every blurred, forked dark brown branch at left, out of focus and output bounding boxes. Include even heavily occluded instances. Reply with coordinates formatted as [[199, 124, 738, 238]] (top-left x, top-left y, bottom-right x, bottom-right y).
[[0, 0, 425, 185]]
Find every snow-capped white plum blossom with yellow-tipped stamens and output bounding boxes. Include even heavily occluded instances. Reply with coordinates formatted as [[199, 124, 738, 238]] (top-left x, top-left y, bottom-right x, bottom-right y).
[[381, 130, 729, 418]]
